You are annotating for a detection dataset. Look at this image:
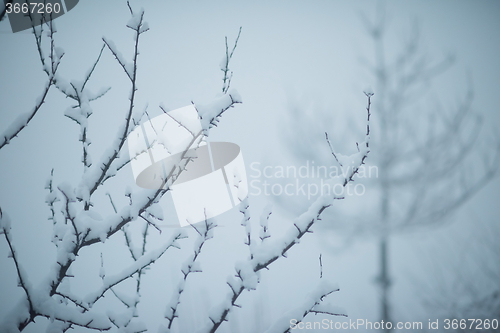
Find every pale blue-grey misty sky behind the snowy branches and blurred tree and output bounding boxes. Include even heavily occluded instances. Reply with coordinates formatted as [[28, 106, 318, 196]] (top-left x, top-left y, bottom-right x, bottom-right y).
[[0, 1, 500, 332]]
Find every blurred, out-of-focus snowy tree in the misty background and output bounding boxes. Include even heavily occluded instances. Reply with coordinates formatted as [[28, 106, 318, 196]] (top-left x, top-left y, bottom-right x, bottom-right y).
[[284, 6, 500, 330]]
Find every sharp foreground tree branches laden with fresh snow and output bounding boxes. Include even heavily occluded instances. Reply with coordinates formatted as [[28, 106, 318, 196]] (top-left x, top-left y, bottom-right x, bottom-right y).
[[0, 4, 372, 332]]
